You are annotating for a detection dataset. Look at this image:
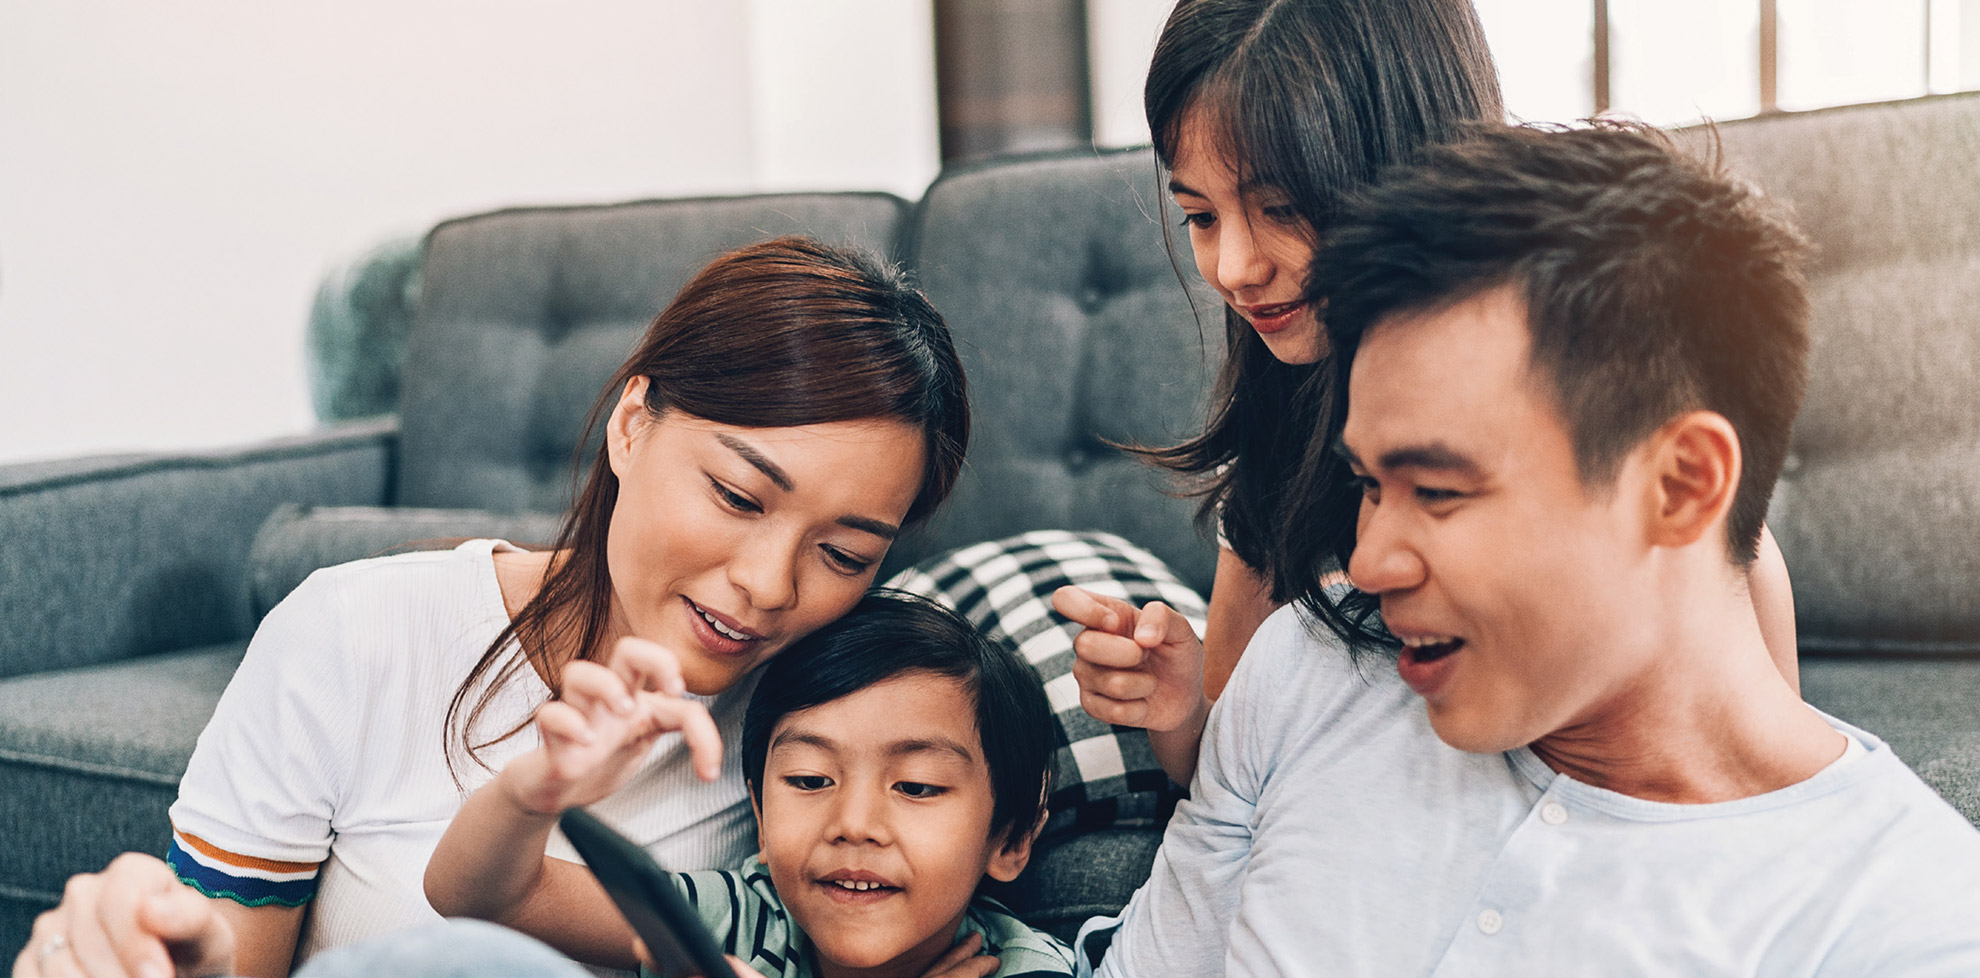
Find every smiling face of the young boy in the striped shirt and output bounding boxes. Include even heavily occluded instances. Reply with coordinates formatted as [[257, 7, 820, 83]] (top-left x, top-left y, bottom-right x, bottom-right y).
[[756, 673, 1030, 974]]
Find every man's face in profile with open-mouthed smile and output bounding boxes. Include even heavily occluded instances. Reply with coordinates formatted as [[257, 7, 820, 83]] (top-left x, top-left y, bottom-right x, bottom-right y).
[[1342, 287, 1653, 752]]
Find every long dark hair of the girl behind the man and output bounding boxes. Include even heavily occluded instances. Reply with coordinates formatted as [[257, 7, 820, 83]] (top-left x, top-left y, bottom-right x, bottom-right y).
[[1144, 0, 1505, 637]]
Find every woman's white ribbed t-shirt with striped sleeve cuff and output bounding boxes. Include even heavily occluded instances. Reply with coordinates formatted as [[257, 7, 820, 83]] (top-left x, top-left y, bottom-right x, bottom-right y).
[[170, 540, 756, 960]]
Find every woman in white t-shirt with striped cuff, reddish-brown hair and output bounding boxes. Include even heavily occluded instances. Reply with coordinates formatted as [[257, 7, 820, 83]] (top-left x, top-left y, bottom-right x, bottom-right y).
[[22, 238, 968, 976]]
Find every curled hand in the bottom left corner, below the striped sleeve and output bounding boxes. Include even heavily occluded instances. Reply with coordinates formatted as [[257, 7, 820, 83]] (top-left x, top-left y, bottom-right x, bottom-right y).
[[14, 853, 234, 978]]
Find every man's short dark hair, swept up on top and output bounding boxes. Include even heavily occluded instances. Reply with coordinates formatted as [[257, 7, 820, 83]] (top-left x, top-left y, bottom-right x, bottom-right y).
[[1287, 121, 1808, 649]]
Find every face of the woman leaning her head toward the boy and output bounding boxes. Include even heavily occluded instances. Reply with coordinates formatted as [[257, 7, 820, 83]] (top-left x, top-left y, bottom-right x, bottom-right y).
[[606, 378, 925, 695]]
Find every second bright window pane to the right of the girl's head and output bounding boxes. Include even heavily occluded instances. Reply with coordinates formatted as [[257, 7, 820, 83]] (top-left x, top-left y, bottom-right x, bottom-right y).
[[1610, 0, 1758, 125]]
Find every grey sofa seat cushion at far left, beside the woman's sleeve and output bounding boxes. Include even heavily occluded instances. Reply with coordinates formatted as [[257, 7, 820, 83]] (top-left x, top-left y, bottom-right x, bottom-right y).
[[0, 641, 248, 954]]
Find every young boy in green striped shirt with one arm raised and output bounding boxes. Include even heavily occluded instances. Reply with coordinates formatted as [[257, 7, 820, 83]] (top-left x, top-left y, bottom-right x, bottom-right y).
[[426, 594, 1073, 978]]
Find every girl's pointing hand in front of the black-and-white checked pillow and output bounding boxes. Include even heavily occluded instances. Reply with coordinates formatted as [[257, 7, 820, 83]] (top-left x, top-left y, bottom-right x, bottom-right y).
[[1051, 586, 1210, 733]]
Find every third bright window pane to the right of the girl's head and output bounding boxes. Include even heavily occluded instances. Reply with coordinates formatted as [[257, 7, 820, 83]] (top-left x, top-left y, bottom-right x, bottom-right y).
[[1778, 0, 1927, 109]]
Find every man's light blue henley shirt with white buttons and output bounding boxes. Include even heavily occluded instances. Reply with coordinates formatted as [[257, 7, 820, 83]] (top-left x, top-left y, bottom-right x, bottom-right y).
[[1089, 610, 1980, 978]]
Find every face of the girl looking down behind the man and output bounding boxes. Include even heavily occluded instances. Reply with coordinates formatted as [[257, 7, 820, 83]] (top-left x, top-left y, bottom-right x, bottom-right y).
[[1168, 109, 1327, 364]]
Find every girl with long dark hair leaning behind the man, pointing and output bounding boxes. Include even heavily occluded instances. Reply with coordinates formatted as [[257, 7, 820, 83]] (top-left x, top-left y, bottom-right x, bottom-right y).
[[1053, 0, 1798, 784]]
